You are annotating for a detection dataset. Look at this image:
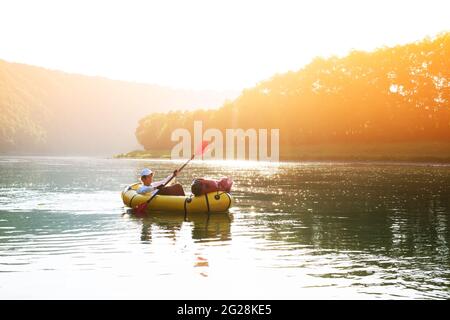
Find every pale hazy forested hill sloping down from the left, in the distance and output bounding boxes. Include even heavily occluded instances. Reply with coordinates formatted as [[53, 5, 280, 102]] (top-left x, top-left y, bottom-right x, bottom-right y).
[[0, 60, 237, 155]]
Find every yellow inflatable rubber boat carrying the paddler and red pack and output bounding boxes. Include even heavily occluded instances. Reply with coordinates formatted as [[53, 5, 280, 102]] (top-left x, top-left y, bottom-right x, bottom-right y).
[[122, 183, 233, 215]]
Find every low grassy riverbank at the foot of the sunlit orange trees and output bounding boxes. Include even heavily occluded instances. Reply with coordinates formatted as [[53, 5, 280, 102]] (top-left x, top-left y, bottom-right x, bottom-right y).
[[114, 142, 450, 163]]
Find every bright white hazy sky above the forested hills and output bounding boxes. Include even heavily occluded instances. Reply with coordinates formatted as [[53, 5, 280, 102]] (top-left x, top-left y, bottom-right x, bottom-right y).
[[0, 0, 450, 90]]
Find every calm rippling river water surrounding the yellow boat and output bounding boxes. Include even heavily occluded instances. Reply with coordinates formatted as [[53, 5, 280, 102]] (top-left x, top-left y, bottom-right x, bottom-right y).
[[0, 157, 450, 299]]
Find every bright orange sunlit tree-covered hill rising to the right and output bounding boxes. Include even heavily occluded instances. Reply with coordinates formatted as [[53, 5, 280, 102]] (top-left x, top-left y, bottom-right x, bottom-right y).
[[136, 33, 450, 153]]
